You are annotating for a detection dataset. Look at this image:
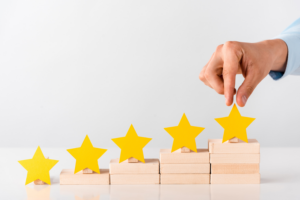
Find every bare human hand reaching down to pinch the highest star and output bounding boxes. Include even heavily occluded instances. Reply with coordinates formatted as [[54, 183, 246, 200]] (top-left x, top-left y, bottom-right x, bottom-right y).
[[199, 39, 288, 107]]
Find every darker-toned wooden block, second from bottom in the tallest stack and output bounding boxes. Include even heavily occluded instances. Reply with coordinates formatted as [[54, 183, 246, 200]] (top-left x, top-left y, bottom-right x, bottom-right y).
[[211, 163, 259, 174]]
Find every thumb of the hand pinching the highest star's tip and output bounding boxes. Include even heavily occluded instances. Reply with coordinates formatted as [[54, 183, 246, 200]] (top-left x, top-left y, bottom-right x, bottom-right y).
[[236, 71, 261, 107]]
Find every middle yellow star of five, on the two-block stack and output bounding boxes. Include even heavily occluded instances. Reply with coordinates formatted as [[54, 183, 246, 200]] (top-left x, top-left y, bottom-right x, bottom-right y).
[[112, 124, 151, 163]]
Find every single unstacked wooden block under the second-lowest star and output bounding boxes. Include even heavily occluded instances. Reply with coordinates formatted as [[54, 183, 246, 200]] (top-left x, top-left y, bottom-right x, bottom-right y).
[[60, 169, 109, 185]]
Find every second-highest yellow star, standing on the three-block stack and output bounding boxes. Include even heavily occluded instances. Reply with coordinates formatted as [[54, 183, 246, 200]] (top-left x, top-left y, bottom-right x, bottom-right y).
[[165, 113, 204, 152]]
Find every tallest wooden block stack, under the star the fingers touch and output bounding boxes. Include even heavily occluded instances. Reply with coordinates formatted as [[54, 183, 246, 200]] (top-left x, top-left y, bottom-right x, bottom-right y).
[[208, 139, 260, 184]]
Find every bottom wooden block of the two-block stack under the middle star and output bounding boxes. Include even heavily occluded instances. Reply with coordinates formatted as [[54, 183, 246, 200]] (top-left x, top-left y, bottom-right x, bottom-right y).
[[110, 174, 160, 185]]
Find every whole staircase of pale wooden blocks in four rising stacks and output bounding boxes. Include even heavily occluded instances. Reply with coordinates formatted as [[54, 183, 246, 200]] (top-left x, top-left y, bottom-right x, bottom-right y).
[[60, 139, 260, 185]]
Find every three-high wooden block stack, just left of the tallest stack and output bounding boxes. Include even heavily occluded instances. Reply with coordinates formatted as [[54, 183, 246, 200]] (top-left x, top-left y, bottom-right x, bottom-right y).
[[160, 147, 210, 184]]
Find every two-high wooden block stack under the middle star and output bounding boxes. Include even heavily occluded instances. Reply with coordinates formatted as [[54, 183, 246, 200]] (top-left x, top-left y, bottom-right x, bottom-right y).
[[109, 158, 159, 185]]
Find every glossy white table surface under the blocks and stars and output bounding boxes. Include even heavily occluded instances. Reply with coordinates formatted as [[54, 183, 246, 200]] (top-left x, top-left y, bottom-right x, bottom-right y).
[[0, 147, 300, 200]]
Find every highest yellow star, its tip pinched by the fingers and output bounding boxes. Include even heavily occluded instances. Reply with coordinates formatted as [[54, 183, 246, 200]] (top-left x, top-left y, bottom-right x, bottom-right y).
[[215, 104, 255, 143]]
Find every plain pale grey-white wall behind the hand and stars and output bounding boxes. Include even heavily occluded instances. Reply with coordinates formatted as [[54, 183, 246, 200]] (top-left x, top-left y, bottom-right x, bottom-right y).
[[0, 0, 300, 149]]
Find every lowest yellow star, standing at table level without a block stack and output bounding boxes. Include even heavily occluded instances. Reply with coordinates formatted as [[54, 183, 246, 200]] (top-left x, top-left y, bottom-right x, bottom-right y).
[[18, 147, 58, 185]]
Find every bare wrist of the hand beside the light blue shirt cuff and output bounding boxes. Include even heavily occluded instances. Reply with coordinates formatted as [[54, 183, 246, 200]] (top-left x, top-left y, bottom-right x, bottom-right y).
[[265, 39, 288, 72]]
